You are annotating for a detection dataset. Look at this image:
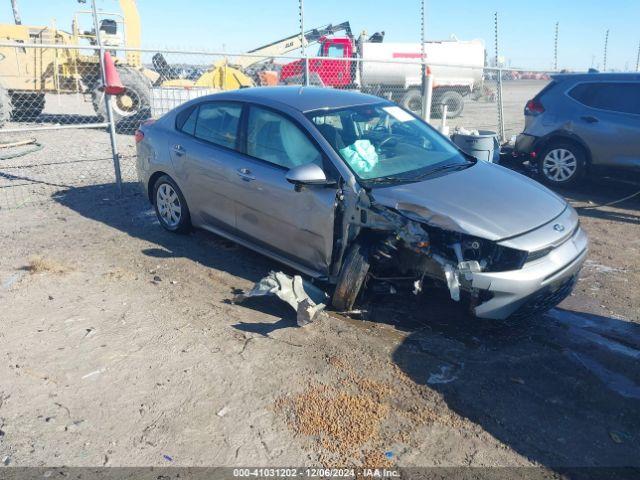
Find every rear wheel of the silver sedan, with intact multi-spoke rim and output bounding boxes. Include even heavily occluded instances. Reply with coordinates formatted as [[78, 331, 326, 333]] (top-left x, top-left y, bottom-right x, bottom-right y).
[[153, 175, 191, 233]]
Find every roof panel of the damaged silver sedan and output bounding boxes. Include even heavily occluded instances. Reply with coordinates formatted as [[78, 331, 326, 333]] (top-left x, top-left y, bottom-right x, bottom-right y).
[[195, 86, 385, 112]]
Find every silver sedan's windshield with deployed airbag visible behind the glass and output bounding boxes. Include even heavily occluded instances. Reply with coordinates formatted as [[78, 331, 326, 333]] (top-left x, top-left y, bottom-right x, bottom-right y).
[[307, 103, 473, 185]]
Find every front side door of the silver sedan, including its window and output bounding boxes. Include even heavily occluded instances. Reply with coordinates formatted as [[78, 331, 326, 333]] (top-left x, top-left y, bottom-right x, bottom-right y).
[[235, 105, 336, 274]]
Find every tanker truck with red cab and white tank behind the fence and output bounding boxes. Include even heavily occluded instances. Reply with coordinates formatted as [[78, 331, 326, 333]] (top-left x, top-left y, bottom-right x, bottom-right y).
[[280, 32, 485, 117]]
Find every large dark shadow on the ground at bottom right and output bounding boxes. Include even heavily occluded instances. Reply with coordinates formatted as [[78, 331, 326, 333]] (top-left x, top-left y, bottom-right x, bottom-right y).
[[393, 292, 640, 472]]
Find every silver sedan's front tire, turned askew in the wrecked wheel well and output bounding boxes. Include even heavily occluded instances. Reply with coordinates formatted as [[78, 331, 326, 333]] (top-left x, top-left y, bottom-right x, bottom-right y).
[[331, 242, 370, 312]]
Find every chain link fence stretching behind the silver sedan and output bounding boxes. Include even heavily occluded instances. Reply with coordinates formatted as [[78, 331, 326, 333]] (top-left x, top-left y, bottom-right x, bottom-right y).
[[0, 43, 549, 208]]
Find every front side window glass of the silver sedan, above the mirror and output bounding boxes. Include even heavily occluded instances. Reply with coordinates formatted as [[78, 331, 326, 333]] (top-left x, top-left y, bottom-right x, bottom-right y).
[[247, 106, 322, 169]]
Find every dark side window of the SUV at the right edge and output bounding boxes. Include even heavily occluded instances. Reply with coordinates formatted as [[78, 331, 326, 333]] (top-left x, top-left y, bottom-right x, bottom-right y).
[[569, 82, 640, 115]]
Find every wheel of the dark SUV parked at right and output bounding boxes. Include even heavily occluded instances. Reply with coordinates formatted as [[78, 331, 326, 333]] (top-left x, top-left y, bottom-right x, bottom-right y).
[[538, 140, 586, 188]]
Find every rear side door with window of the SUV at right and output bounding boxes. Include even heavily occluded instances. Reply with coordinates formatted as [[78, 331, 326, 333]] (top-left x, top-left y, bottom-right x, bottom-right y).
[[569, 82, 640, 167]]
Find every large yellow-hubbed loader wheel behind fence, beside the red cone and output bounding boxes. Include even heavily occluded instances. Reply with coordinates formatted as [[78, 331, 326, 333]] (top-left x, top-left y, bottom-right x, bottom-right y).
[[91, 66, 152, 133]]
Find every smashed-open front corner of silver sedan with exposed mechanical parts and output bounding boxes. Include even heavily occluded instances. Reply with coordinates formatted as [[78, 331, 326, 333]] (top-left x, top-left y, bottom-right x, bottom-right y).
[[332, 191, 528, 314]]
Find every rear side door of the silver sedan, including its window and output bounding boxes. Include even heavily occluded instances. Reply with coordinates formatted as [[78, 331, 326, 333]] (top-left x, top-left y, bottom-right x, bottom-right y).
[[169, 101, 242, 232]]
